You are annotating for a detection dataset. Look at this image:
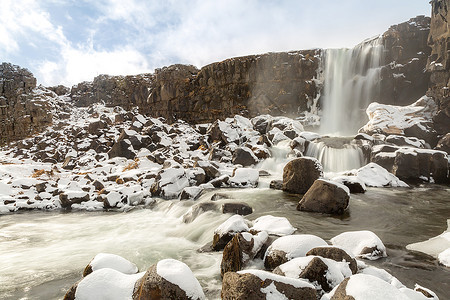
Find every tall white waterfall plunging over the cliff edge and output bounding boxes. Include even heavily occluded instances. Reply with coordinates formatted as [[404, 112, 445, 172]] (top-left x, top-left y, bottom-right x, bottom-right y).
[[320, 37, 384, 135]]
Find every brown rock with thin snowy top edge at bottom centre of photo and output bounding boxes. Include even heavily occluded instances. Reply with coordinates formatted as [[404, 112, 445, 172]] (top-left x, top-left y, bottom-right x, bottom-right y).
[[221, 270, 317, 300]]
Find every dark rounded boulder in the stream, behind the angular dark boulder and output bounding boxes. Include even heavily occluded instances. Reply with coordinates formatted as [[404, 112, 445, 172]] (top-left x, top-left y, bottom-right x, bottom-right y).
[[283, 157, 323, 194]]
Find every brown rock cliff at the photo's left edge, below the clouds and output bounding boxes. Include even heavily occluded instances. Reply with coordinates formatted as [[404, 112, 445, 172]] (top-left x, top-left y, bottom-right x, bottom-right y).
[[0, 63, 52, 144]]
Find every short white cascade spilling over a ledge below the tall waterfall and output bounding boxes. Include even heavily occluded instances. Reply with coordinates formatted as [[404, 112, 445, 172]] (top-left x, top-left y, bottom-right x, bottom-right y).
[[305, 137, 365, 173]]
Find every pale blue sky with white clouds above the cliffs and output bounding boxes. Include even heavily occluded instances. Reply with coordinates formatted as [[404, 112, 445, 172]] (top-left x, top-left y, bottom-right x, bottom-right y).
[[0, 0, 431, 87]]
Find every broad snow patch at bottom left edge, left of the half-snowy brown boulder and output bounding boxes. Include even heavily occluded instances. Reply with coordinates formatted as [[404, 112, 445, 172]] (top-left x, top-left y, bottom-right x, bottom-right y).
[[75, 268, 145, 300]]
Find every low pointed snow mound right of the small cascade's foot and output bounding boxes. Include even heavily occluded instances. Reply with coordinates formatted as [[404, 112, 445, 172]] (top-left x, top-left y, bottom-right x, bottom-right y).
[[349, 163, 408, 187]]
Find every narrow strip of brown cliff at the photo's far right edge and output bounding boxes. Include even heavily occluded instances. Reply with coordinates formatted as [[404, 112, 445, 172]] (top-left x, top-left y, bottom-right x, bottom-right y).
[[427, 0, 450, 134]]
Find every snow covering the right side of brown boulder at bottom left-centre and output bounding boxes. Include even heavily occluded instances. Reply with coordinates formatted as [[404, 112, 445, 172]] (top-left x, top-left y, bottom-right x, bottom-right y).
[[156, 259, 205, 299]]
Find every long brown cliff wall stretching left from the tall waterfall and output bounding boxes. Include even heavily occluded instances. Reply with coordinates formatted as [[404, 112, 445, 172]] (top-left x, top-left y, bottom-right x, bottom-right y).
[[71, 50, 320, 123]]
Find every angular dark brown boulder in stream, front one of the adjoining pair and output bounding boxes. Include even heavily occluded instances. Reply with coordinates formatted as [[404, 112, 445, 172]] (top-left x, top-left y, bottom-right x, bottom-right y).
[[297, 179, 350, 214]]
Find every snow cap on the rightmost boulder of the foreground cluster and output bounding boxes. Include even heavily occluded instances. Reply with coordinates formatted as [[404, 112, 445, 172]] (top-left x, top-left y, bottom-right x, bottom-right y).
[[330, 230, 387, 260]]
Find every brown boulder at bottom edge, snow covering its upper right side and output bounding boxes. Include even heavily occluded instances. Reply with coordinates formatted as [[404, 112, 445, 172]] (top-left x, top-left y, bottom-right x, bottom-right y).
[[133, 259, 205, 300]]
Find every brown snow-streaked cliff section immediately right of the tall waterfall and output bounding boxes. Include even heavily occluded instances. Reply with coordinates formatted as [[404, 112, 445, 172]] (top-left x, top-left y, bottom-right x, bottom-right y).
[[378, 16, 431, 105]]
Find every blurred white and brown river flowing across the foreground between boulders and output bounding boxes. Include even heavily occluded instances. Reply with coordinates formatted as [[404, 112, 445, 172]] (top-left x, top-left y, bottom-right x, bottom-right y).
[[0, 185, 450, 299]]
